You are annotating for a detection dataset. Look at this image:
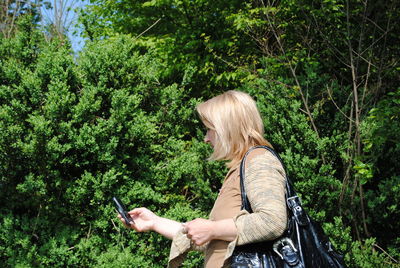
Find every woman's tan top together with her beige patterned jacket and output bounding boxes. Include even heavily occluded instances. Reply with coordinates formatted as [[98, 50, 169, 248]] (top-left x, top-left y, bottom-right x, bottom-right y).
[[168, 149, 287, 268]]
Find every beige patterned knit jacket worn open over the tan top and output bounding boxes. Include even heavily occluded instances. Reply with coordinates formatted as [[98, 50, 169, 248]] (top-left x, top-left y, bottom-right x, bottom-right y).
[[168, 149, 287, 268]]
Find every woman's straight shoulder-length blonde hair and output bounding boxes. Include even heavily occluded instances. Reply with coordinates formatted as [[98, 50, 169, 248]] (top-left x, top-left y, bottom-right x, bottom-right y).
[[196, 90, 271, 168]]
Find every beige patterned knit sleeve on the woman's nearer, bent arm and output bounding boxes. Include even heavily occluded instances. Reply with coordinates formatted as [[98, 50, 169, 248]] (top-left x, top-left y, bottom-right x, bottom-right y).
[[233, 151, 287, 245]]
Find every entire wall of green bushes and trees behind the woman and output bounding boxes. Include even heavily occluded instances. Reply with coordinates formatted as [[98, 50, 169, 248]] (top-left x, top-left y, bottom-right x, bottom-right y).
[[0, 0, 400, 267]]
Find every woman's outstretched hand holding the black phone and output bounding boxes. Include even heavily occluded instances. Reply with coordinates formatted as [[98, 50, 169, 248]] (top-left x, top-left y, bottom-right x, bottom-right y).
[[118, 208, 158, 232]]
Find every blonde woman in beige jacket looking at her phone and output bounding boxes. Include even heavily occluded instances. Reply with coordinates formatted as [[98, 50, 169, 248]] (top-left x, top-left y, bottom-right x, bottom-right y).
[[119, 91, 287, 268]]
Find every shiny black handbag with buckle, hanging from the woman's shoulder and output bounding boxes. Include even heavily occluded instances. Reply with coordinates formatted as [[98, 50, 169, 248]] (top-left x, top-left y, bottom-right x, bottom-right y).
[[231, 146, 345, 268]]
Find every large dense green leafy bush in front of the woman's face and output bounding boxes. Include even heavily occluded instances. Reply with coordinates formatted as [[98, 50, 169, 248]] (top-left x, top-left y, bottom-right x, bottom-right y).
[[0, 16, 223, 267]]
